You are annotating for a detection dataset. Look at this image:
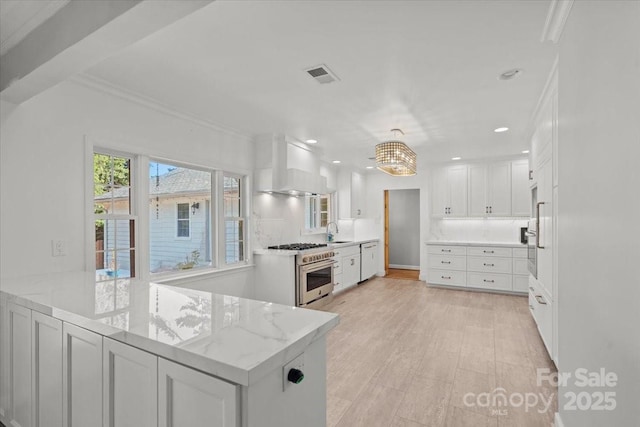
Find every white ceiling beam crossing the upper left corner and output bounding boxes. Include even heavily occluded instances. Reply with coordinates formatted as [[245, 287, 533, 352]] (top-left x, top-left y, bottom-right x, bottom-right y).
[[0, 0, 213, 104]]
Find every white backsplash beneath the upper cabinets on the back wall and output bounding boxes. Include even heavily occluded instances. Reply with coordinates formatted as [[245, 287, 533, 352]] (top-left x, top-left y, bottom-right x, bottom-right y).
[[429, 218, 527, 243]]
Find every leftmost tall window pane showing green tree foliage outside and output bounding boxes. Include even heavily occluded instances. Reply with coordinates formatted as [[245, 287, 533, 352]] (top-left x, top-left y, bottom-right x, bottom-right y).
[[93, 153, 136, 282]]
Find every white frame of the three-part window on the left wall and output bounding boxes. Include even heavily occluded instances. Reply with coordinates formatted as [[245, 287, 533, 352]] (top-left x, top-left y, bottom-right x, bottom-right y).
[[84, 136, 253, 283]]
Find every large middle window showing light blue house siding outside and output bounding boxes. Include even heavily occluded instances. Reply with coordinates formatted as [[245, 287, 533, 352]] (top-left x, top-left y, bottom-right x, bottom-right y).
[[149, 161, 214, 273]]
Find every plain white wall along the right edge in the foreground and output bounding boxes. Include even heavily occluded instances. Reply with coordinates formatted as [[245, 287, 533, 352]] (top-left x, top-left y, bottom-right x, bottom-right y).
[[557, 1, 640, 427]]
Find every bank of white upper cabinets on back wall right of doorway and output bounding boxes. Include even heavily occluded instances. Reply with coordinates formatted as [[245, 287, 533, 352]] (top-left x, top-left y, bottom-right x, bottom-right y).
[[431, 159, 529, 218]]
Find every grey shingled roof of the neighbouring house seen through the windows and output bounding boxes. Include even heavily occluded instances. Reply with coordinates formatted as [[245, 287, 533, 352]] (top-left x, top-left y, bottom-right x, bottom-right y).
[[94, 168, 211, 200]]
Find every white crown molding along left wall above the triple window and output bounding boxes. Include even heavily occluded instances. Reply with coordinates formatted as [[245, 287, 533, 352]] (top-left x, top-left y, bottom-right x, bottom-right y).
[[69, 73, 253, 142]]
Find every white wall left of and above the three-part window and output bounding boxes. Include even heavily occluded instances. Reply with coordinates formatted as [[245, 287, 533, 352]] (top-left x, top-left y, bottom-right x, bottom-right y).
[[0, 82, 253, 296]]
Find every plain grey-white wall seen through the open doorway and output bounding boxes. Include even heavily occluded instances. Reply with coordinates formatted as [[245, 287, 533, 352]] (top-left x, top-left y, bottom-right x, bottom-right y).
[[389, 189, 420, 268]]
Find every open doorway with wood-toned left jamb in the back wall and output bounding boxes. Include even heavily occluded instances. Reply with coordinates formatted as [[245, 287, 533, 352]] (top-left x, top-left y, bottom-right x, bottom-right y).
[[384, 189, 420, 280]]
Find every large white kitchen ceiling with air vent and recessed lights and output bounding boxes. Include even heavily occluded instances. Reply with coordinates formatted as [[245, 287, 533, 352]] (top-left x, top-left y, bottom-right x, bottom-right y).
[[87, 0, 556, 167]]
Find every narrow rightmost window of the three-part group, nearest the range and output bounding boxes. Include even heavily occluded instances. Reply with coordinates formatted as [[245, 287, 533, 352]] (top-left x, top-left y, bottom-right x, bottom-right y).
[[224, 174, 245, 264]]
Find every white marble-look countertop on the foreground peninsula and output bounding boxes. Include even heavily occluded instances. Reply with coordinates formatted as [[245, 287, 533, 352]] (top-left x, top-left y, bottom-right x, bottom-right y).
[[0, 272, 339, 386]]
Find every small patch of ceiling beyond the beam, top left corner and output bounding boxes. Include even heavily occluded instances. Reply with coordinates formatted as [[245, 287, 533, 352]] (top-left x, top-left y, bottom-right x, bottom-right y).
[[0, 0, 69, 55]]
